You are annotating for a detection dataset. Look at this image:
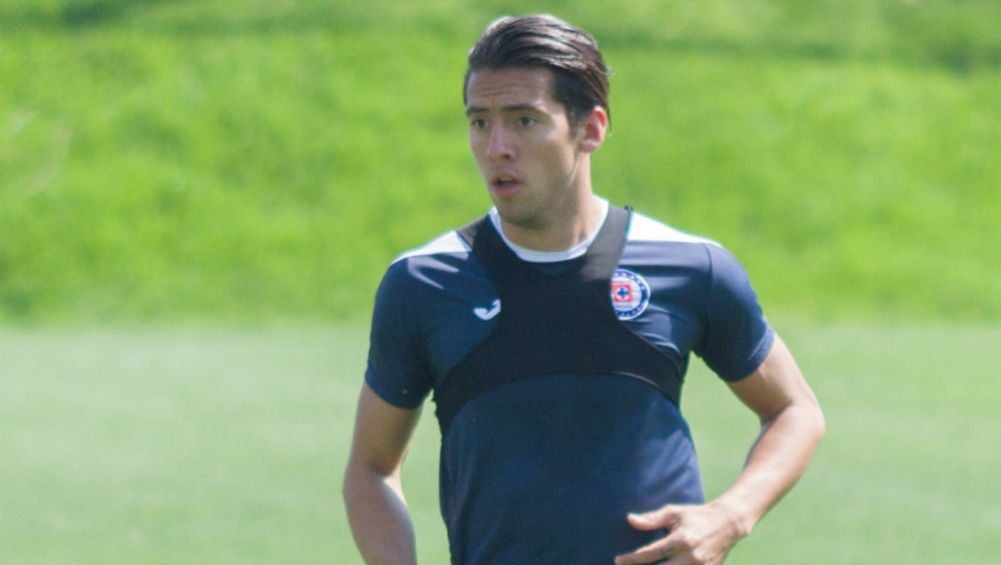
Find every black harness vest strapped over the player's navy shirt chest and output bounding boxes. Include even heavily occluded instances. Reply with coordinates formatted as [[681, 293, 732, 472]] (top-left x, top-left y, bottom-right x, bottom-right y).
[[434, 206, 681, 433]]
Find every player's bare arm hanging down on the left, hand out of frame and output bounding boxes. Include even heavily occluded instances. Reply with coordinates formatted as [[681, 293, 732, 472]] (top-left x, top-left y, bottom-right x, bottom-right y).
[[343, 384, 420, 565]]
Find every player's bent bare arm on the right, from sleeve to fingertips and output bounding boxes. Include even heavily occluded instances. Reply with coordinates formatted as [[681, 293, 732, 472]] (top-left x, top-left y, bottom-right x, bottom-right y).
[[616, 337, 825, 565]]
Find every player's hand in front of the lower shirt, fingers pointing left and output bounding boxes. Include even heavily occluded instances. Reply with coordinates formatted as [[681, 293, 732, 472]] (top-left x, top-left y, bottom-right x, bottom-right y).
[[616, 504, 744, 565]]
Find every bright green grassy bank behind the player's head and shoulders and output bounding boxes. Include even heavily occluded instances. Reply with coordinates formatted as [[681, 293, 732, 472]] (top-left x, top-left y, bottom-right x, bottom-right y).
[[0, 0, 1001, 324]]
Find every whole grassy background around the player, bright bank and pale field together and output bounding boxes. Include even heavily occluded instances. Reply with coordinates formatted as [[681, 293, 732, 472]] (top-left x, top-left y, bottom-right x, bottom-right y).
[[0, 0, 1001, 564]]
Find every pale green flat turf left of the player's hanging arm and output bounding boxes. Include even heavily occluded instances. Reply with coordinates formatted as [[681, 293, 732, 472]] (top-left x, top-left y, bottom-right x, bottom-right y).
[[0, 330, 363, 564]]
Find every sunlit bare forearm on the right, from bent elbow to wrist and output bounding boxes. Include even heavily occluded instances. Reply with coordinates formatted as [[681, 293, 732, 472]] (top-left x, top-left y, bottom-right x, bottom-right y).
[[713, 399, 825, 537]]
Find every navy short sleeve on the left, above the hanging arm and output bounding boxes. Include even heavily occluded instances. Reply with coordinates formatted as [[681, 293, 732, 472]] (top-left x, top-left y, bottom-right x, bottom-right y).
[[365, 259, 431, 409]]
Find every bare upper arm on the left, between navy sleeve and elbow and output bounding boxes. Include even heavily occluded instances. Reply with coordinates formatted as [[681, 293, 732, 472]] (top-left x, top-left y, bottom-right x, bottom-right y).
[[348, 383, 420, 476]]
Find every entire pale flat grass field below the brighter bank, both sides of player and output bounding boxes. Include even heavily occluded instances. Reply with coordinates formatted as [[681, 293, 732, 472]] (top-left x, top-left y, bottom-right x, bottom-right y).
[[0, 323, 1001, 565]]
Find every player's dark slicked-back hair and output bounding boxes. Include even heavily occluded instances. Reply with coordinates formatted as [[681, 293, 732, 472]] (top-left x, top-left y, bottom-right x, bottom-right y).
[[462, 14, 612, 127]]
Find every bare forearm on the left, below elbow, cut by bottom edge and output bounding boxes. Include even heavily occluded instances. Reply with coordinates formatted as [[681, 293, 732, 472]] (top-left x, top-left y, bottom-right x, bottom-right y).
[[343, 465, 416, 565]]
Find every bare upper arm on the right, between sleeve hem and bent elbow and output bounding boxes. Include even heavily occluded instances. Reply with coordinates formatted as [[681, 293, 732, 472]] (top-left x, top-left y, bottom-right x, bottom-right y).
[[728, 336, 817, 422]]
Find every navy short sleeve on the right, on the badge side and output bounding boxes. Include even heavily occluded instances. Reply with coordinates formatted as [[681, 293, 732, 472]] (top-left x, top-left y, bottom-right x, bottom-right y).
[[695, 244, 775, 381]]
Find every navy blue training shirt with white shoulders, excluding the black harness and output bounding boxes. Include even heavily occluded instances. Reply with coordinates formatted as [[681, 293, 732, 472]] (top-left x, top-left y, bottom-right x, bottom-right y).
[[365, 204, 773, 565]]
